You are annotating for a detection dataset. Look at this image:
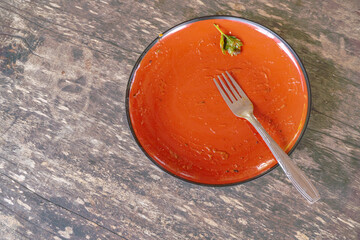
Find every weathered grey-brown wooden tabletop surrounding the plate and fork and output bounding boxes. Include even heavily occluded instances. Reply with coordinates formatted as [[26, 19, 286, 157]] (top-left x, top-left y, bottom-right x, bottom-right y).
[[0, 0, 360, 240]]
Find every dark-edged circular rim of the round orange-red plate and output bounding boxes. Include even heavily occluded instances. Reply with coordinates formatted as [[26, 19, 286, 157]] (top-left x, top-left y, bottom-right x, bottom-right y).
[[125, 15, 312, 187]]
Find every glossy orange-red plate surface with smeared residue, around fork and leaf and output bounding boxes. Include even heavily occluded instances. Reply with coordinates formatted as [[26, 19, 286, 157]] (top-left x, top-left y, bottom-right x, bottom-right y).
[[129, 19, 309, 184]]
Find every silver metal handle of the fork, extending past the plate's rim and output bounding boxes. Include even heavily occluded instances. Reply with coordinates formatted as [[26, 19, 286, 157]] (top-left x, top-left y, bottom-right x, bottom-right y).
[[246, 114, 320, 204]]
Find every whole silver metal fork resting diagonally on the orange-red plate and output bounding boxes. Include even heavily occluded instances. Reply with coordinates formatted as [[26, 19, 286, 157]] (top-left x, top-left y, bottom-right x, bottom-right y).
[[213, 71, 320, 204]]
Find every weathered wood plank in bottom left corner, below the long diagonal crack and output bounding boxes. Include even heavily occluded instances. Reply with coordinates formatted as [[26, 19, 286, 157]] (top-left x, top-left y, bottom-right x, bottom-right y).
[[0, 173, 128, 239]]
